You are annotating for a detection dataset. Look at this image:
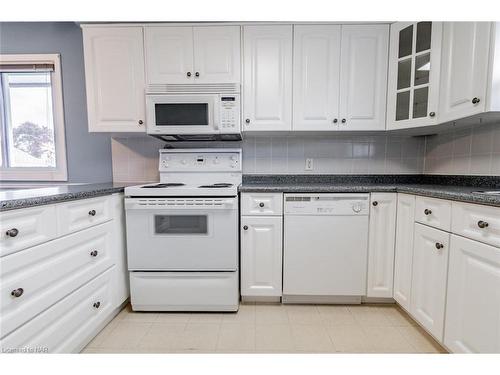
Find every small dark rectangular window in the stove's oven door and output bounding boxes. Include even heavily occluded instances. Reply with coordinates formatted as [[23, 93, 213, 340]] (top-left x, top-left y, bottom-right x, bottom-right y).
[[155, 215, 208, 234]]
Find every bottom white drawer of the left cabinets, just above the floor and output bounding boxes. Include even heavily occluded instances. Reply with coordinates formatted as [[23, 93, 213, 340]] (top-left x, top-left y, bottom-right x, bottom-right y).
[[0, 267, 114, 353]]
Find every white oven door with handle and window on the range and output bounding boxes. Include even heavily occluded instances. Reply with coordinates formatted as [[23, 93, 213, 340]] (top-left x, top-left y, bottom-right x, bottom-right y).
[[125, 197, 238, 271]]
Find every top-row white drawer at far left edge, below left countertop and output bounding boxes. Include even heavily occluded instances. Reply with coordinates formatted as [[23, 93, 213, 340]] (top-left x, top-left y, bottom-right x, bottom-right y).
[[0, 206, 57, 256]]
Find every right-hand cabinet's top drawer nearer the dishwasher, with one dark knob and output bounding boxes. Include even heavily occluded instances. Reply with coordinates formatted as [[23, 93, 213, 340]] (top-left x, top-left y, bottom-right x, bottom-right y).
[[415, 197, 451, 232]]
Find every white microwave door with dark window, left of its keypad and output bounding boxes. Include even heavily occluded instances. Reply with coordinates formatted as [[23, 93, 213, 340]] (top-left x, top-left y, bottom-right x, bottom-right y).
[[146, 94, 219, 135]]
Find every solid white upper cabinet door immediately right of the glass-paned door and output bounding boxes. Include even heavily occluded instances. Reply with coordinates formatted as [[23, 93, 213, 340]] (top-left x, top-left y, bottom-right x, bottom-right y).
[[439, 22, 491, 122]]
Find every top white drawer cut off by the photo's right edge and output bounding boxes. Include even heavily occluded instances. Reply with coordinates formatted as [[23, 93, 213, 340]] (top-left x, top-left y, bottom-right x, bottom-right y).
[[451, 202, 500, 247]]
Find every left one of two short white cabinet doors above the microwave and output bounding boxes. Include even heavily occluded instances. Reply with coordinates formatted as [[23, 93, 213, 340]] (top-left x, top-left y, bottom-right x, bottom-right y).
[[144, 26, 195, 85]]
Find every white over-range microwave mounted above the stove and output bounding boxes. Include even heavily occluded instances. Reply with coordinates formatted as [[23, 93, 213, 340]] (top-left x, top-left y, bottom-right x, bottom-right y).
[[146, 93, 241, 141]]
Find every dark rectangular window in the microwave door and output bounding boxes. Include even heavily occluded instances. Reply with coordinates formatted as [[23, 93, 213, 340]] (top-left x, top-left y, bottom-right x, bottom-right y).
[[155, 103, 208, 126]]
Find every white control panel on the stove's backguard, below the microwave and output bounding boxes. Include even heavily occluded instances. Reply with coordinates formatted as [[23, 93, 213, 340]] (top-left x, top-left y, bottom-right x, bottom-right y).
[[159, 149, 241, 172]]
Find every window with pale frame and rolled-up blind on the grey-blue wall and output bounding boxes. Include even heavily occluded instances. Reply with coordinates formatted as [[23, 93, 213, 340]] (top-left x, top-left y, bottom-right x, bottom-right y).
[[0, 54, 67, 181]]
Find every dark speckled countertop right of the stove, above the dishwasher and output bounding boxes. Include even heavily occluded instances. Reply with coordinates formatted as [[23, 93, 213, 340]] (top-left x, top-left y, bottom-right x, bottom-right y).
[[240, 175, 500, 206]]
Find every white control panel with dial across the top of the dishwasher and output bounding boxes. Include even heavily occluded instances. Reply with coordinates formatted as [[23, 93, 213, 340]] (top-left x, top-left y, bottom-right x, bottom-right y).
[[284, 193, 370, 216]]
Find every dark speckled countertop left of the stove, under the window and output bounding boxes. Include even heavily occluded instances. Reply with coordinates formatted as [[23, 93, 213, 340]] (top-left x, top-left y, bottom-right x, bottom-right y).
[[0, 182, 129, 211]]
